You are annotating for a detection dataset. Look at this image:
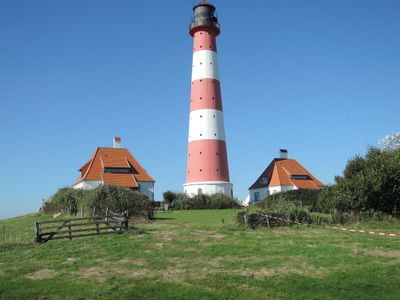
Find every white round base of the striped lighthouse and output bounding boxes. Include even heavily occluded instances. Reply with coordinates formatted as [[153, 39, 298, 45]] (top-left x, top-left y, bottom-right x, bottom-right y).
[[183, 181, 233, 198]]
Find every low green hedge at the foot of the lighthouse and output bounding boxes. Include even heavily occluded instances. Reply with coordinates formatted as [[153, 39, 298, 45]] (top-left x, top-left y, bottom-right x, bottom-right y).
[[168, 192, 241, 210]]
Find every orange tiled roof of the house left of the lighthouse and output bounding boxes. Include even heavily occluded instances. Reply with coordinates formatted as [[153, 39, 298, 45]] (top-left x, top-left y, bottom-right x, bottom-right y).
[[75, 147, 154, 187]]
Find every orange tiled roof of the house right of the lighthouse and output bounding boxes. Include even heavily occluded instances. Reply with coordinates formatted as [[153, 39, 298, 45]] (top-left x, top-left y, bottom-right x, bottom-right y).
[[249, 158, 325, 189]]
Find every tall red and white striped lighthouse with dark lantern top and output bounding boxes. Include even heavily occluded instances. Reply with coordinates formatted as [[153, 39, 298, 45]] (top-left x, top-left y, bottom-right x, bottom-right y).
[[183, 2, 233, 197]]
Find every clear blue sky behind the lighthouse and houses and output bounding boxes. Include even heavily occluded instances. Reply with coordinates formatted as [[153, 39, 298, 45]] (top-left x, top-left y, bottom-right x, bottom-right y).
[[0, 0, 400, 219]]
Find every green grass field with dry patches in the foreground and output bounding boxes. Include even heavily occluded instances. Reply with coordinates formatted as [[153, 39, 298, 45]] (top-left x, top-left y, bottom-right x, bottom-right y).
[[0, 210, 400, 299]]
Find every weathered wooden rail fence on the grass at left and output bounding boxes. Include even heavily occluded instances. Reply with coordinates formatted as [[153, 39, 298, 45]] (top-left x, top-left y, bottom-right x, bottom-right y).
[[35, 209, 128, 243]]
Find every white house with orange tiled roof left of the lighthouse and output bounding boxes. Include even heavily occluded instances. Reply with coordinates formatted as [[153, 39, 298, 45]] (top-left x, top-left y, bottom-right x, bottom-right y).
[[73, 137, 155, 199]]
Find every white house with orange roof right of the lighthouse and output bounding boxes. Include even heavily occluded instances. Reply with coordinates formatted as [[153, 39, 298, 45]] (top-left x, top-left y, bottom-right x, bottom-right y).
[[249, 149, 325, 203]]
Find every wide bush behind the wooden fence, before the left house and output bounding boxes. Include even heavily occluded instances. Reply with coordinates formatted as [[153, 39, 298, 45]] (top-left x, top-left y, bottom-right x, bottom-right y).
[[42, 185, 155, 219]]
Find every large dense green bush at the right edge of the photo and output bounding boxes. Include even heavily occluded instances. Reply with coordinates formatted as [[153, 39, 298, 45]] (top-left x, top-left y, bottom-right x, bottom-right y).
[[316, 148, 400, 213]]
